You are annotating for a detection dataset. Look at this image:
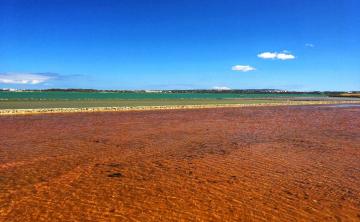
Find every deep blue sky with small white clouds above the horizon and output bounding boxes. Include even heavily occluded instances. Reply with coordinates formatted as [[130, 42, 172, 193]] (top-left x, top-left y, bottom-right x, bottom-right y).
[[0, 0, 360, 90]]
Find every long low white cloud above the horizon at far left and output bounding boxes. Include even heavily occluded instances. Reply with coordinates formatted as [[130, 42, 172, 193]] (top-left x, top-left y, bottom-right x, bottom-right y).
[[0, 73, 56, 85]]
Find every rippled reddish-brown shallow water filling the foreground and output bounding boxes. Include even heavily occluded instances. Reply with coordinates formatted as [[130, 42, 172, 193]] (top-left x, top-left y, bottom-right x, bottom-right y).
[[0, 107, 360, 221]]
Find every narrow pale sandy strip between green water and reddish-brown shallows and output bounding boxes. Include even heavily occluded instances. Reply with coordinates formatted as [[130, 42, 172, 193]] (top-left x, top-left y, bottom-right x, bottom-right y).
[[0, 101, 360, 116]]
